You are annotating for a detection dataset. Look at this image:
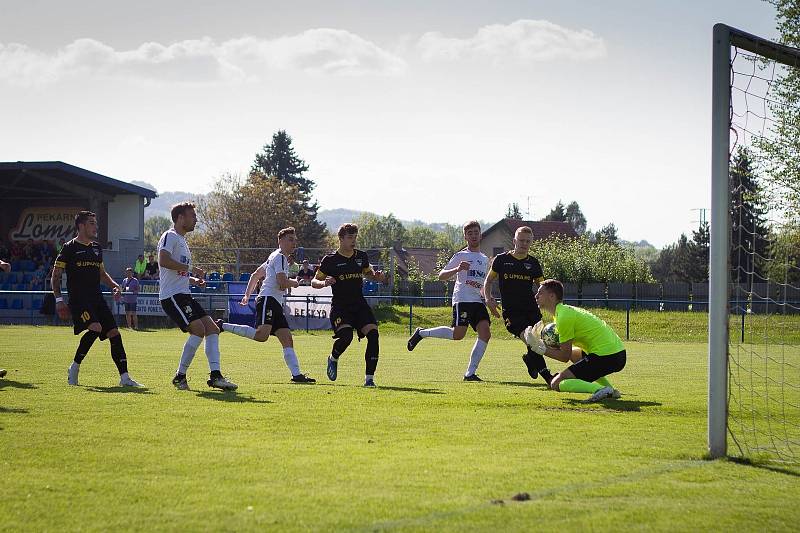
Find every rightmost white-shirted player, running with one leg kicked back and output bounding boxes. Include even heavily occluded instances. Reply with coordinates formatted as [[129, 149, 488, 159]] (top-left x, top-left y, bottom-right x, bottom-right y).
[[408, 220, 492, 381]]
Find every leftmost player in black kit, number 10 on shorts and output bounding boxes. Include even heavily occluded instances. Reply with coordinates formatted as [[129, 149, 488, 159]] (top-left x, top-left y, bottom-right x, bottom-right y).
[[50, 211, 142, 387]]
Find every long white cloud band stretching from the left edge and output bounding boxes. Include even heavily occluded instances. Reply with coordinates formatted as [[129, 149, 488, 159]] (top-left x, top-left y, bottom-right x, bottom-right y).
[[0, 29, 405, 86]]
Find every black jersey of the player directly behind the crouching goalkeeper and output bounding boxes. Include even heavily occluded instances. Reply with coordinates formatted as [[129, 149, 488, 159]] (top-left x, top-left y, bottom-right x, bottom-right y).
[[492, 252, 544, 311]]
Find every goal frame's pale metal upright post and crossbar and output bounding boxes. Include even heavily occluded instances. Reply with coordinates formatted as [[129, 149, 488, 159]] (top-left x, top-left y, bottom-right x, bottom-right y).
[[708, 24, 800, 458]]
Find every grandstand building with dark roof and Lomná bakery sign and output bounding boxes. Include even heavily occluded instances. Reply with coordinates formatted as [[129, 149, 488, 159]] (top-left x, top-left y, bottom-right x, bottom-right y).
[[0, 161, 157, 277]]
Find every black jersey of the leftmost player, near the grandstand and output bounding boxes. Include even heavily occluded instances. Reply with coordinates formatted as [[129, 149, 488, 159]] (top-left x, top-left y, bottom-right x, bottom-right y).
[[55, 238, 104, 301]]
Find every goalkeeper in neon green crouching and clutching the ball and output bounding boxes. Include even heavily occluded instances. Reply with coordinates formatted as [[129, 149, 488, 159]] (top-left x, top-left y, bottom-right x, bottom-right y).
[[525, 279, 626, 402]]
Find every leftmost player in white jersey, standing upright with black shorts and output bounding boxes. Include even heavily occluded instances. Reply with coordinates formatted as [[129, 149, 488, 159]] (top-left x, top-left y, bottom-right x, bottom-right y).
[[158, 202, 237, 390]]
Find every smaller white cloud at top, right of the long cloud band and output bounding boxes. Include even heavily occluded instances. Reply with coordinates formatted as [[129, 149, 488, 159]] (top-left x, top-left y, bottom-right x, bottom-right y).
[[417, 20, 606, 62]]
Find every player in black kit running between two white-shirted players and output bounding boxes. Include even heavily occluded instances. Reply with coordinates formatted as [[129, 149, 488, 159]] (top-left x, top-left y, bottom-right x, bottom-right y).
[[311, 224, 386, 387]]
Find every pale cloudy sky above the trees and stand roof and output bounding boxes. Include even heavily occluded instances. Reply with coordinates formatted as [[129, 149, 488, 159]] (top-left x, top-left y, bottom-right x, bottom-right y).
[[0, 0, 774, 246]]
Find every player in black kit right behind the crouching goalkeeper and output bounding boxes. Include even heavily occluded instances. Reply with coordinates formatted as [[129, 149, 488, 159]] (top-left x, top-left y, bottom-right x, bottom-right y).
[[482, 226, 553, 384]]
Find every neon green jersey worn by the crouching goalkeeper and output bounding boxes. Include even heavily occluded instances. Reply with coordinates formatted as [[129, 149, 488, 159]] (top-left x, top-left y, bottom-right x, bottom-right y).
[[555, 303, 625, 355]]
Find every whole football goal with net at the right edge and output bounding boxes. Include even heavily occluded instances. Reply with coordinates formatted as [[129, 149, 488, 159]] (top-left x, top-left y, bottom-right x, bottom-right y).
[[709, 24, 800, 462]]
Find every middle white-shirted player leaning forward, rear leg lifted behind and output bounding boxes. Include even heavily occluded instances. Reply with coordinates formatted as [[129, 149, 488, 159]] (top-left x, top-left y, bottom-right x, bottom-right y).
[[217, 227, 316, 383]]
